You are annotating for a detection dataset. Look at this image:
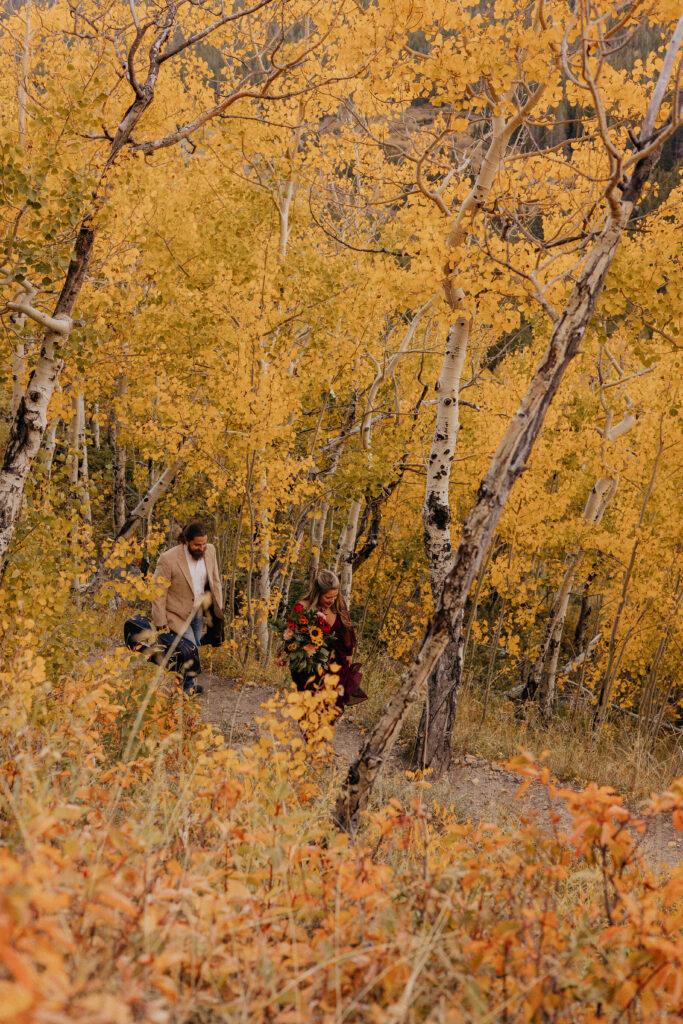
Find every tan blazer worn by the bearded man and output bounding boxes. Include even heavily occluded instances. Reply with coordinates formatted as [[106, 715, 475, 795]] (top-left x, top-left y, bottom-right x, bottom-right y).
[[152, 544, 223, 633]]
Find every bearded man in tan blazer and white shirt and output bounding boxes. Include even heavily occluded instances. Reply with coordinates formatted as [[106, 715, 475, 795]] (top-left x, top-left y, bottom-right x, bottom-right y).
[[152, 519, 223, 693]]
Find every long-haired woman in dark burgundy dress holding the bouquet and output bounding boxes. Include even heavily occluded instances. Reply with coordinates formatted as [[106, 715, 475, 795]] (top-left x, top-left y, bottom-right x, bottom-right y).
[[284, 569, 368, 709]]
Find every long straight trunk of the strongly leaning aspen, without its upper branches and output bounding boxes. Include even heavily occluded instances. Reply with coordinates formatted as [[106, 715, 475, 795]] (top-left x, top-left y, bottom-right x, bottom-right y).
[[334, 121, 667, 831]]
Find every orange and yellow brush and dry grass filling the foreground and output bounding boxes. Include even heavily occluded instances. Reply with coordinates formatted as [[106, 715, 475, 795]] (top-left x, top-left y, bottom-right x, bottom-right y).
[[0, 638, 683, 1024]]
